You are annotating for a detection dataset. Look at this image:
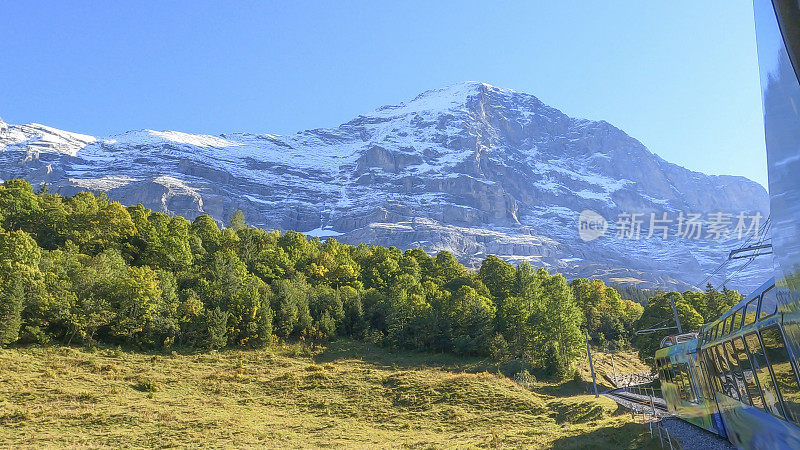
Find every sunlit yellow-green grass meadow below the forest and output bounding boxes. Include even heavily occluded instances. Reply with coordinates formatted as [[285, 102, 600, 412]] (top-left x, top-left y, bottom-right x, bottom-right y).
[[0, 340, 657, 449]]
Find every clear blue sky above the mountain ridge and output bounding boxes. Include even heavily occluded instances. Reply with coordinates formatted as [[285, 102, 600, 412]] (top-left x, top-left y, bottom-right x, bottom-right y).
[[0, 0, 766, 184]]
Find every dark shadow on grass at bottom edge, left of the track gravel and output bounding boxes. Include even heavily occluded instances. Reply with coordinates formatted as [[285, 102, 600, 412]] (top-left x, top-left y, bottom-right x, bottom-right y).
[[553, 423, 661, 450]]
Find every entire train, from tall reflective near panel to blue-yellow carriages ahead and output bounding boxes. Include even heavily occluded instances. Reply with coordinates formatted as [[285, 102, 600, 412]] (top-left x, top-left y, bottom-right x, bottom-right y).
[[656, 0, 800, 449]]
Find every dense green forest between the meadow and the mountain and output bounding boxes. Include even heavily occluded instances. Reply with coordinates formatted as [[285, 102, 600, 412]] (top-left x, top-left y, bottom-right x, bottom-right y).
[[0, 180, 740, 377]]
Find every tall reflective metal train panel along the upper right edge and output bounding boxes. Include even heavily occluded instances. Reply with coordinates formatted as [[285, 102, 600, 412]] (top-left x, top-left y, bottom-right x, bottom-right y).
[[753, 0, 800, 355]]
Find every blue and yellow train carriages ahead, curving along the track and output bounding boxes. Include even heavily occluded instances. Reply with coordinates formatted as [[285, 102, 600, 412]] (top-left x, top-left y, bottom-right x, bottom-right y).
[[655, 279, 800, 449]]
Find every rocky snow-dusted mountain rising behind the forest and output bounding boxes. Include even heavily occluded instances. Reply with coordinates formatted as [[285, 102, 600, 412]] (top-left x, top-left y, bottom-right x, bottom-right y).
[[0, 82, 769, 289]]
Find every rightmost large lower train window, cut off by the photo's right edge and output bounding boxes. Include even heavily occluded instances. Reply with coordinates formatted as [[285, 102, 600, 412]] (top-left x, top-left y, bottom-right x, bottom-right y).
[[761, 326, 800, 424]]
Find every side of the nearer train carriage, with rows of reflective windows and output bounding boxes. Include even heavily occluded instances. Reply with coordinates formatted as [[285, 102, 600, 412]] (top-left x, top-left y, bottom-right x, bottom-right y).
[[697, 280, 800, 448]]
